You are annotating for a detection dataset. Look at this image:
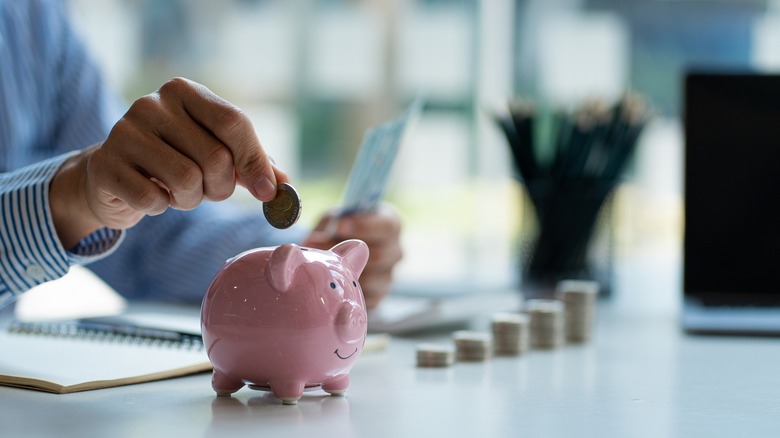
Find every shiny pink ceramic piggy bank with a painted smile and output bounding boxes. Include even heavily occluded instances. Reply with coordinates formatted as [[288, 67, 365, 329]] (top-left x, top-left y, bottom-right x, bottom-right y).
[[201, 240, 368, 404]]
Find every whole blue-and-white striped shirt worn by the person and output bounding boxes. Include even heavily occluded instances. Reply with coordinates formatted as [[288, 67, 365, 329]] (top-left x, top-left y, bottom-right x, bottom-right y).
[[0, 0, 302, 306]]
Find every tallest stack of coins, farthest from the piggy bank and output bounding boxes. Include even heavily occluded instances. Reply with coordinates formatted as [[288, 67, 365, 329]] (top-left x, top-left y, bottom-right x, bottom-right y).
[[555, 280, 599, 343]]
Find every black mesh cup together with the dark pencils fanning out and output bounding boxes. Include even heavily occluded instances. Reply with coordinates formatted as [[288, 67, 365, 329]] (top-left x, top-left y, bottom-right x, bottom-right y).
[[495, 94, 649, 297]]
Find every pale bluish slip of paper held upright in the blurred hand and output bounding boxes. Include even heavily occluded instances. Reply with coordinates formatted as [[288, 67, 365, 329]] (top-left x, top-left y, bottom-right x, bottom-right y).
[[341, 99, 423, 214]]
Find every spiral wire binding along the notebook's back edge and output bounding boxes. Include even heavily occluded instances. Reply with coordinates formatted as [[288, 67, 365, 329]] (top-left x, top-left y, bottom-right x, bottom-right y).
[[8, 321, 203, 351]]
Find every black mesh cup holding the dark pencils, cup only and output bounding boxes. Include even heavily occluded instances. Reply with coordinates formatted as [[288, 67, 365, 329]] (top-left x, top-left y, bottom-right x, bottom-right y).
[[519, 181, 615, 298]]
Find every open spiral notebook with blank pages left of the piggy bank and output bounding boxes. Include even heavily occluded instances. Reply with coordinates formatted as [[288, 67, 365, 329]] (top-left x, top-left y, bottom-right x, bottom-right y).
[[0, 314, 212, 394]]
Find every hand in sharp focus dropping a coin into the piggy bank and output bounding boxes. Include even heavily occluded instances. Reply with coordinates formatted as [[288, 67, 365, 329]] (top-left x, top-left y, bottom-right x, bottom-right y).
[[50, 78, 288, 248]]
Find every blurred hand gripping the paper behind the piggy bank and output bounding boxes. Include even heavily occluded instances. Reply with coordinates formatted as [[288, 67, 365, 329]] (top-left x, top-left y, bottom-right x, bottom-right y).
[[302, 205, 403, 309]]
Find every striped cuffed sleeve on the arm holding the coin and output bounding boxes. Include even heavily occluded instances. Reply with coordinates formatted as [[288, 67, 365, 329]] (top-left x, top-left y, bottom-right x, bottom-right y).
[[0, 154, 124, 307]]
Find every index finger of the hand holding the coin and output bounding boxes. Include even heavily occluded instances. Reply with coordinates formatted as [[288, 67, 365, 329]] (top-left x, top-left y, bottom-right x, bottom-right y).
[[159, 78, 286, 201]]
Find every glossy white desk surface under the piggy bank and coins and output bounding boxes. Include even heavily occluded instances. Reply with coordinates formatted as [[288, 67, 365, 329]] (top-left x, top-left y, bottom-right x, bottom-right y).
[[0, 305, 780, 438]]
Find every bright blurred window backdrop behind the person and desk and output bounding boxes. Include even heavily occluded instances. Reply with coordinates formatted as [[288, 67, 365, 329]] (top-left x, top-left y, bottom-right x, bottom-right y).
[[62, 0, 780, 312]]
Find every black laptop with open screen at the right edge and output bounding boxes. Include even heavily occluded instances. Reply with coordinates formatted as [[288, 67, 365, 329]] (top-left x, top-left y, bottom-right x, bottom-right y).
[[682, 71, 780, 335]]
